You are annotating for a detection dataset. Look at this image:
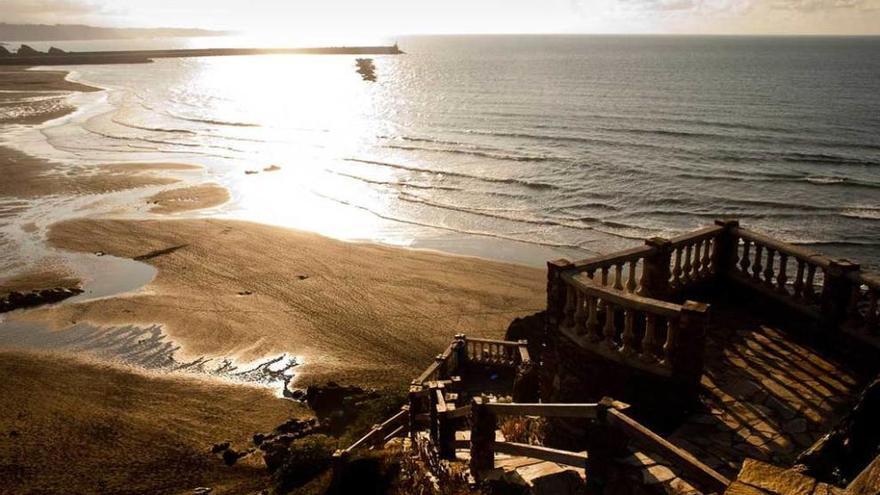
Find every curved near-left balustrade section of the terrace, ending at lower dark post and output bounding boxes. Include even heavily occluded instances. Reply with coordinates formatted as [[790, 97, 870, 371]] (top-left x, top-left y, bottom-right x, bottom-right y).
[[559, 273, 708, 381]]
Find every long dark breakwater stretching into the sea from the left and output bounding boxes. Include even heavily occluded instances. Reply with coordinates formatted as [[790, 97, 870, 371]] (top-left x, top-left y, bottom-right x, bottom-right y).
[[0, 44, 404, 66]]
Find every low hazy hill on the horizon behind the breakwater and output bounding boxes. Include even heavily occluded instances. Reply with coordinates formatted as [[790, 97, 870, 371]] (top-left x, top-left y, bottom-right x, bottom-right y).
[[0, 23, 230, 41]]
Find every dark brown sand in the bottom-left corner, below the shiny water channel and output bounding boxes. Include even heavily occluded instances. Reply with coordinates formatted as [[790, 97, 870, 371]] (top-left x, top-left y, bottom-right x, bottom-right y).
[[0, 351, 308, 494]]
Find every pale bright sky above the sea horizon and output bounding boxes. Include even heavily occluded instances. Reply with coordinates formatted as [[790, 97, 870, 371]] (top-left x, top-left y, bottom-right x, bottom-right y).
[[0, 0, 880, 38]]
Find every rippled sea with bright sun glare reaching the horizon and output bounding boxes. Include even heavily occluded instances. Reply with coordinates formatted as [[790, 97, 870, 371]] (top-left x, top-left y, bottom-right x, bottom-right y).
[[0, 36, 880, 267]]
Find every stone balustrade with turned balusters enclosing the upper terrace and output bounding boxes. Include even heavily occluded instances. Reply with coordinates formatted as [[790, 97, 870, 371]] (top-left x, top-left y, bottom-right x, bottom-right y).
[[545, 220, 880, 396]]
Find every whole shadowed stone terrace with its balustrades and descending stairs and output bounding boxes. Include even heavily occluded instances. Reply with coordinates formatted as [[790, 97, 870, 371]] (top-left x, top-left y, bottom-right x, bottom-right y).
[[336, 220, 880, 495]]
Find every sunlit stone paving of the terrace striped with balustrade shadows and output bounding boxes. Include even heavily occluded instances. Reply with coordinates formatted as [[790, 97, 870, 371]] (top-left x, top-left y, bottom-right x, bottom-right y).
[[669, 305, 859, 478]]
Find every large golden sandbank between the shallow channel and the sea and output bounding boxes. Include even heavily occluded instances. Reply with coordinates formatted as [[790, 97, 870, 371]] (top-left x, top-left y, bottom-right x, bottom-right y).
[[11, 219, 545, 386]]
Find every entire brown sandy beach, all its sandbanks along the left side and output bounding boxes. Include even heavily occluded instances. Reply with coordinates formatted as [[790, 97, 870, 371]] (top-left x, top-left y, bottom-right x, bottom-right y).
[[0, 70, 545, 493]]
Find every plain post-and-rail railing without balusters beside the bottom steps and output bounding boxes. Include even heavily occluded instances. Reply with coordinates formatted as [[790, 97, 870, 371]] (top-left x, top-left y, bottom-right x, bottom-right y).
[[467, 397, 730, 493]]
